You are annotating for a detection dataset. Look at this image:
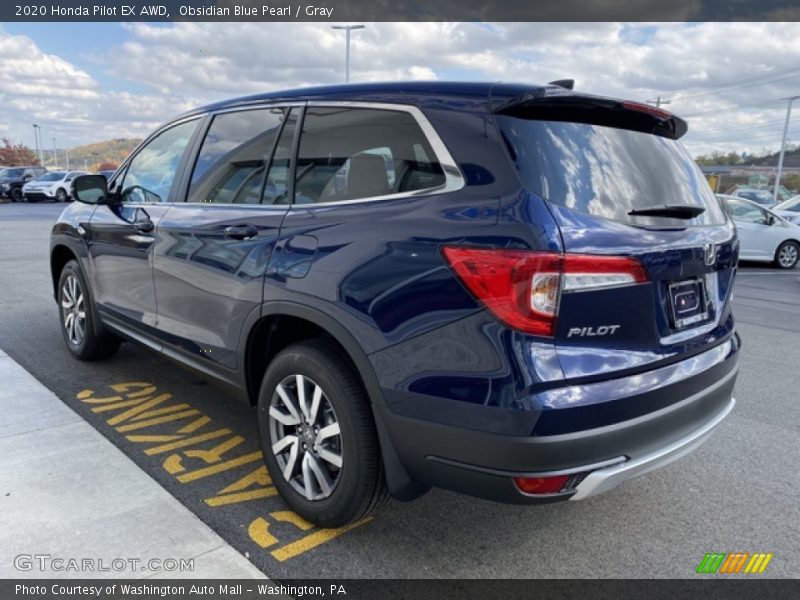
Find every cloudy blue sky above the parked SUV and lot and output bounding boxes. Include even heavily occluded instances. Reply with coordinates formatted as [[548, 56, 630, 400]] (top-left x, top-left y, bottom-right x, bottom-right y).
[[0, 22, 800, 156]]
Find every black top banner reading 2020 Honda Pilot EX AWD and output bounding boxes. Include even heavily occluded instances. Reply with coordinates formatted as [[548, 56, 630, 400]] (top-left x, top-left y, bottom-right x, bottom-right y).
[[0, 0, 800, 22]]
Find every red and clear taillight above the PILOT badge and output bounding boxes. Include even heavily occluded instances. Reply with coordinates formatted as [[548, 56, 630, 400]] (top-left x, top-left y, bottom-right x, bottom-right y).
[[443, 246, 648, 337]]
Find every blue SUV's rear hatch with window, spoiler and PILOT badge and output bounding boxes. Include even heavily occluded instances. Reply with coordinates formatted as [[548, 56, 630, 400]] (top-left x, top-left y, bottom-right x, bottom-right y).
[[494, 90, 738, 379]]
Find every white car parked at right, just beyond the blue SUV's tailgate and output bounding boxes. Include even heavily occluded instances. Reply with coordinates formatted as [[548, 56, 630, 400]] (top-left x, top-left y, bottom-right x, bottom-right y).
[[718, 195, 800, 269]]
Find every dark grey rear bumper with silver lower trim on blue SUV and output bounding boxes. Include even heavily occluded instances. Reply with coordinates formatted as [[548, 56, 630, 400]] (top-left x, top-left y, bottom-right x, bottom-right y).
[[376, 344, 738, 504]]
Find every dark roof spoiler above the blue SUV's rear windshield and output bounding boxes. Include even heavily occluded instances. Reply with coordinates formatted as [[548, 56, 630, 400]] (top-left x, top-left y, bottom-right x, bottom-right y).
[[492, 86, 689, 140]]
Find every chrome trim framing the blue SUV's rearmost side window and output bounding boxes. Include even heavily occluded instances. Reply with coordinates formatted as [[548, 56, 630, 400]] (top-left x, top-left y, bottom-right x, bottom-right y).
[[289, 100, 466, 211]]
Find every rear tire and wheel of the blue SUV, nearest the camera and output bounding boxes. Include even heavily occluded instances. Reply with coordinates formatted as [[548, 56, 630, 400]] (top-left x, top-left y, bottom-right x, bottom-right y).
[[258, 340, 387, 527]]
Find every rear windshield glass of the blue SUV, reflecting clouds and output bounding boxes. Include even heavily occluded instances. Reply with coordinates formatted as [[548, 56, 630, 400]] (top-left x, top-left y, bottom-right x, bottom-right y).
[[497, 115, 725, 227]]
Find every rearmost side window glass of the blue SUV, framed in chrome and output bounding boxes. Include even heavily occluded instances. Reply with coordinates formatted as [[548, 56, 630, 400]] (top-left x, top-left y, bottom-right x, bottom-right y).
[[295, 108, 445, 204]]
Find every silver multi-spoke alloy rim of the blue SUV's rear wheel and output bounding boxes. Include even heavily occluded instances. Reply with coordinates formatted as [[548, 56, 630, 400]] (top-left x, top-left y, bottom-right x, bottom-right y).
[[269, 374, 343, 501]]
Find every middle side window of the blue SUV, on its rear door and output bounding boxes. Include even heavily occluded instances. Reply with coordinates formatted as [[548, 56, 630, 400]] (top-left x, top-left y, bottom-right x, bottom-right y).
[[189, 108, 288, 204]]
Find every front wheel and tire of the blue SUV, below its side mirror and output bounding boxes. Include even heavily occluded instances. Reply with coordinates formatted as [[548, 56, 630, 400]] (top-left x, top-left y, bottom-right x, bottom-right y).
[[58, 260, 122, 360]]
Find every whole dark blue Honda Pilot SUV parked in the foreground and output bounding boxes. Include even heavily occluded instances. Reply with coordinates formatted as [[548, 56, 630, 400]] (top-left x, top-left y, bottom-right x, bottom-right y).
[[51, 82, 739, 526]]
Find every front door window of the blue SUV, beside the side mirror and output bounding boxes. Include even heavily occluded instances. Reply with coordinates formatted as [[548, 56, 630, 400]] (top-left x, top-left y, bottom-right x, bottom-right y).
[[120, 119, 198, 204]]
